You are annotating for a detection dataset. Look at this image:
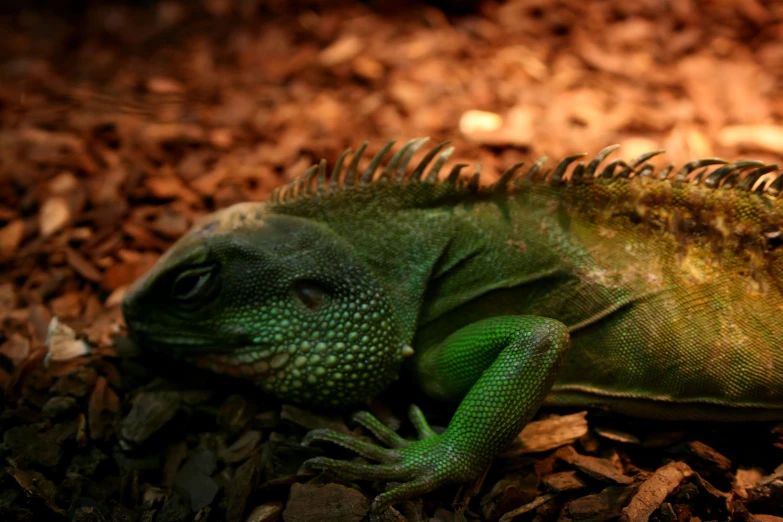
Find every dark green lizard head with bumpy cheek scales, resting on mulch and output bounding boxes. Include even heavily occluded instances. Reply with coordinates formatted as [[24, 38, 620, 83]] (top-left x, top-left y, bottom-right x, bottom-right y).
[[122, 204, 409, 406]]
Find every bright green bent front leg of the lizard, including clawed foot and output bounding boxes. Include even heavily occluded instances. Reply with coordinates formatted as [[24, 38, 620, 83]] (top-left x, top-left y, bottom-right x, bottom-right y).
[[305, 316, 569, 513]]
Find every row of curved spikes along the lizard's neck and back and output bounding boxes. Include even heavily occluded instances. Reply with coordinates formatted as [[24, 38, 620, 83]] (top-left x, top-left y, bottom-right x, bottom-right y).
[[270, 138, 783, 205]]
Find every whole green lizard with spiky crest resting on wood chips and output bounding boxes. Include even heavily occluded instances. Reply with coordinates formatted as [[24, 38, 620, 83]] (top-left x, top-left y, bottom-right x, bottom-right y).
[[123, 140, 783, 512]]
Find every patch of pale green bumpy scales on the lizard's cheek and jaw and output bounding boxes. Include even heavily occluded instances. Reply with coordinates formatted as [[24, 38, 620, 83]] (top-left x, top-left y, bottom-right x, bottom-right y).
[[194, 292, 403, 406]]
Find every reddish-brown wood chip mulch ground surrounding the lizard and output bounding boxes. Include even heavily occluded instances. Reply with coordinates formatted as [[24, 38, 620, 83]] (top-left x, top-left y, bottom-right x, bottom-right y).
[[0, 0, 783, 522]]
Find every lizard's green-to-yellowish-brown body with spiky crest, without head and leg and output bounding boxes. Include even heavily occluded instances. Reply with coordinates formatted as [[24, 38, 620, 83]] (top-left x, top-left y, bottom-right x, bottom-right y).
[[269, 141, 783, 419]]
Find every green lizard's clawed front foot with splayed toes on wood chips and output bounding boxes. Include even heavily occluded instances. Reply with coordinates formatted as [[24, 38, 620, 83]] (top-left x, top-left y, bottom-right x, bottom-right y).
[[302, 405, 481, 514]]
